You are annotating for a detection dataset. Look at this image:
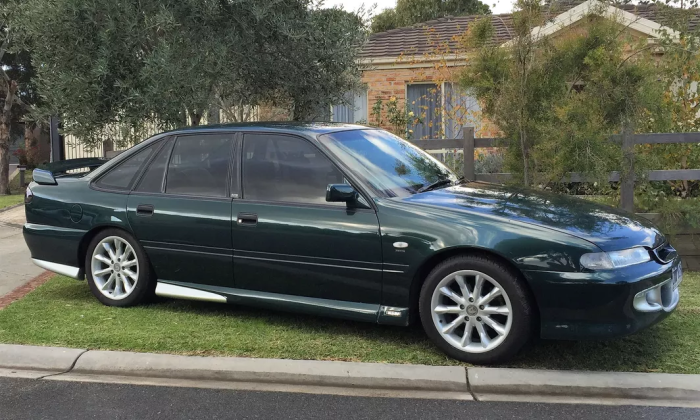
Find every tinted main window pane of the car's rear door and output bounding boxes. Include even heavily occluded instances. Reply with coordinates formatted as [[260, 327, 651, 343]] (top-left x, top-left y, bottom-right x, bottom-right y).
[[165, 134, 233, 197]]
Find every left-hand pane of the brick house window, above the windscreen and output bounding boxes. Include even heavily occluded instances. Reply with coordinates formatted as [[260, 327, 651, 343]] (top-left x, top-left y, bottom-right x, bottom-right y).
[[406, 83, 442, 140]]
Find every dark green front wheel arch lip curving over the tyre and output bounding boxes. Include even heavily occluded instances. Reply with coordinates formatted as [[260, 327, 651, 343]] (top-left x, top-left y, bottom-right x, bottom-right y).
[[409, 246, 540, 323]]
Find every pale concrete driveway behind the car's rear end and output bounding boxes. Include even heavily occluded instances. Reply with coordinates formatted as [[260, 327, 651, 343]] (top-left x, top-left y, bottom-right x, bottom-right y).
[[0, 206, 44, 297]]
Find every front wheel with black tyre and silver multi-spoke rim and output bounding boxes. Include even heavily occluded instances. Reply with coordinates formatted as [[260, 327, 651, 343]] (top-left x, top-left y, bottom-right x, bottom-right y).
[[418, 255, 536, 364]]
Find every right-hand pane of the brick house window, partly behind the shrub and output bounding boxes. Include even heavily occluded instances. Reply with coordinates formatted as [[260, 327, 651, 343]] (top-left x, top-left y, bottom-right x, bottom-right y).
[[443, 82, 481, 139]]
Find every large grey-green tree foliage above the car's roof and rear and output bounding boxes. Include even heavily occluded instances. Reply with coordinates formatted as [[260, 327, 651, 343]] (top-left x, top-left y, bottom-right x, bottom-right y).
[[15, 0, 365, 145]]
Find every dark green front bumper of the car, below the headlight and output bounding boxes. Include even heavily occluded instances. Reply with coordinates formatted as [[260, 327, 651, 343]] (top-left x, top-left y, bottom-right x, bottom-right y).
[[525, 257, 681, 340]]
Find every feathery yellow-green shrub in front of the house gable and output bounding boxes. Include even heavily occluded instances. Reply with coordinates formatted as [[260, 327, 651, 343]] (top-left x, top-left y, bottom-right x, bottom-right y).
[[460, 0, 663, 185]]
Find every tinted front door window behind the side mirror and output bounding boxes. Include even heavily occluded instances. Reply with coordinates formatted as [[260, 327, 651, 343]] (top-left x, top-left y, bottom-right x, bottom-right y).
[[243, 134, 346, 207]]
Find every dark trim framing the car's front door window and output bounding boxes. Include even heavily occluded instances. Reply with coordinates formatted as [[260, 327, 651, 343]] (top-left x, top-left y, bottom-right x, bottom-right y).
[[237, 130, 377, 213]]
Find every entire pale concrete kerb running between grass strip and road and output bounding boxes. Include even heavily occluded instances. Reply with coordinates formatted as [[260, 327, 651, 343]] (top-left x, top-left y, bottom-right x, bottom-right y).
[[0, 344, 700, 407]]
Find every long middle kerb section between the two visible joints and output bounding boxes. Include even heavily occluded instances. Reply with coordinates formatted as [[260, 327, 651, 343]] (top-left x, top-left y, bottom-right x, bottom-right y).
[[64, 351, 469, 398]]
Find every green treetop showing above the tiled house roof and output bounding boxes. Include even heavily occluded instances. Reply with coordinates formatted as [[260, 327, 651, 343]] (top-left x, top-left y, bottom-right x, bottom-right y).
[[371, 0, 490, 33]]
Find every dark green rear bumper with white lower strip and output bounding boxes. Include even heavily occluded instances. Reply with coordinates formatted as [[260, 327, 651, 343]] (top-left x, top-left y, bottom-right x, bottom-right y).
[[23, 223, 86, 279]]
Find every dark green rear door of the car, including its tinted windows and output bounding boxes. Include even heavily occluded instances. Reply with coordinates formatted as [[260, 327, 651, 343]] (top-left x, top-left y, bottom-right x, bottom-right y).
[[127, 133, 238, 287]]
